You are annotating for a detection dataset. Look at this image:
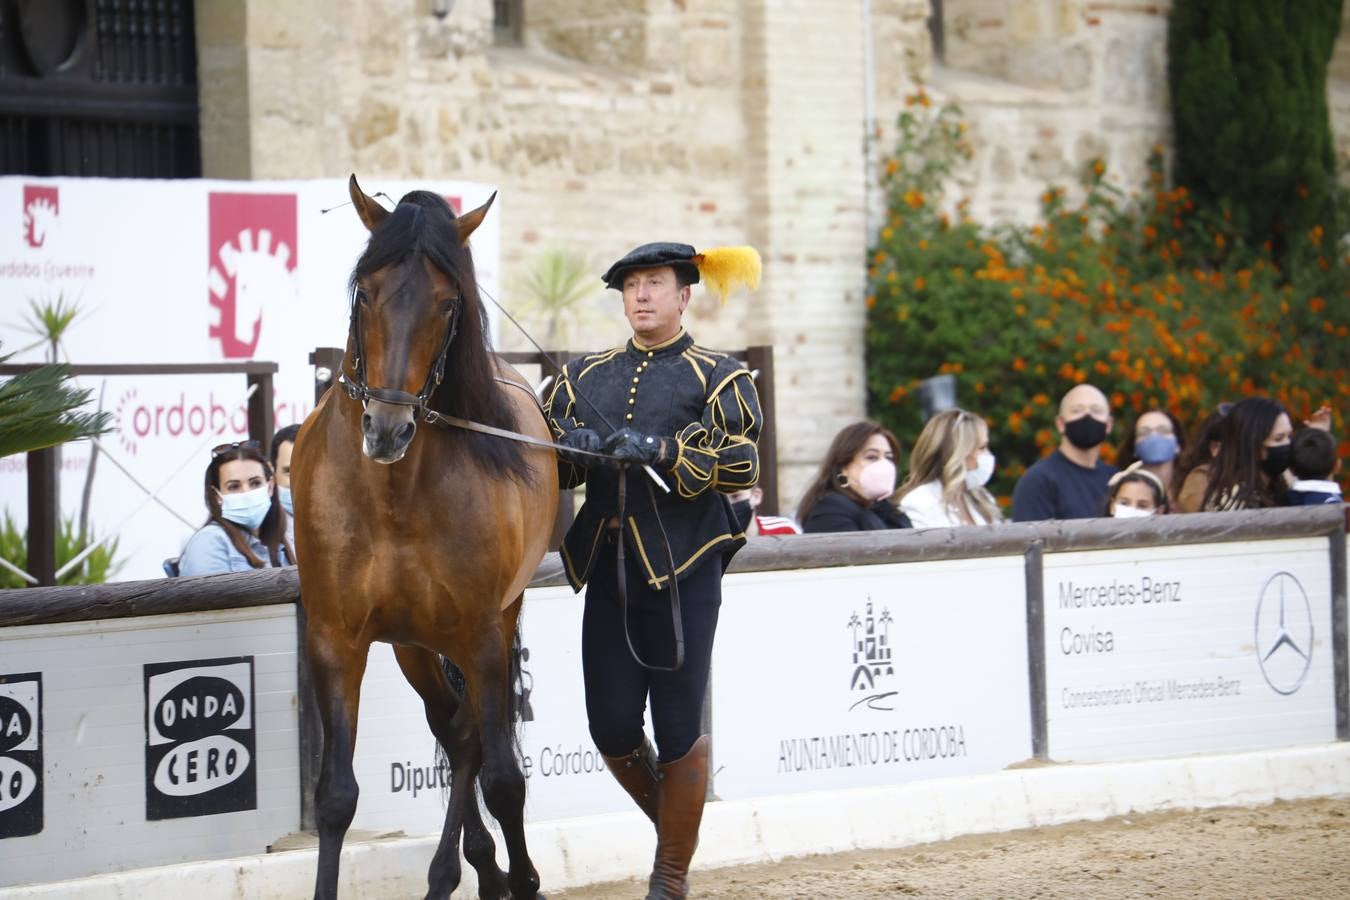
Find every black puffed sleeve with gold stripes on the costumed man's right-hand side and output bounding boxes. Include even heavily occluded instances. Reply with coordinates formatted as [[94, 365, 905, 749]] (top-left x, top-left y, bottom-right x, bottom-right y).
[[671, 360, 764, 498]]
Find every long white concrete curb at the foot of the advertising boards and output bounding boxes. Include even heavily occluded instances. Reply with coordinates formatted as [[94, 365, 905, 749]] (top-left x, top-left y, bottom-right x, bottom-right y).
[[10, 743, 1350, 900]]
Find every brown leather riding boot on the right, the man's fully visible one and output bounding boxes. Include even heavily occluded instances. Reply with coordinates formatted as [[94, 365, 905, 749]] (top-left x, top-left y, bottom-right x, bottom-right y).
[[647, 734, 709, 900]]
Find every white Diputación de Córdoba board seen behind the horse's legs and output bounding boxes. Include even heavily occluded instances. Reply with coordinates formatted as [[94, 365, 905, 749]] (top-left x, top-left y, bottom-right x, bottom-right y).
[[352, 587, 637, 834]]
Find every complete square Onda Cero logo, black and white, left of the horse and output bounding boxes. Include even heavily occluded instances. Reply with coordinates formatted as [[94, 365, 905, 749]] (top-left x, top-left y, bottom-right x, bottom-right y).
[[144, 656, 258, 819]]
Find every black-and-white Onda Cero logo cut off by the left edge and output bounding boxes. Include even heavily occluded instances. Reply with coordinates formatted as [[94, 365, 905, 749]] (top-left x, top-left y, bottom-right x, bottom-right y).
[[0, 672, 42, 838]]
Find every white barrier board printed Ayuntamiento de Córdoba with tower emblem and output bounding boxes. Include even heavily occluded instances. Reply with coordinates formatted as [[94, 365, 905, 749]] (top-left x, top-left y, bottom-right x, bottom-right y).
[[713, 556, 1031, 800]]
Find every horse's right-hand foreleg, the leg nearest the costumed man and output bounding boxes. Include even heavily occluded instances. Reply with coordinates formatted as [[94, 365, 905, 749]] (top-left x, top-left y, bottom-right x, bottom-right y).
[[471, 598, 540, 900]]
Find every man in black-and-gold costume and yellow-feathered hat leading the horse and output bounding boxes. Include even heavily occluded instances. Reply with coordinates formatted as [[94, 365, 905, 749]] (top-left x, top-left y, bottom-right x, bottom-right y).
[[547, 243, 761, 900]]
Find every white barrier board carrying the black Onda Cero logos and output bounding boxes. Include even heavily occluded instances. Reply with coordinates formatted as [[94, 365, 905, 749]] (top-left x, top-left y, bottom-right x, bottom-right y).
[[0, 606, 300, 885]]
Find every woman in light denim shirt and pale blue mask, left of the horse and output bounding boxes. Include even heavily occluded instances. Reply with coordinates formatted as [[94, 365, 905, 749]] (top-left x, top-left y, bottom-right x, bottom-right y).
[[178, 441, 296, 575]]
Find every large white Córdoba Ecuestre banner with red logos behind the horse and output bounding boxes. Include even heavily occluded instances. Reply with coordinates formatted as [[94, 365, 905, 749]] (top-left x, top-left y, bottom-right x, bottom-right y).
[[0, 177, 502, 579]]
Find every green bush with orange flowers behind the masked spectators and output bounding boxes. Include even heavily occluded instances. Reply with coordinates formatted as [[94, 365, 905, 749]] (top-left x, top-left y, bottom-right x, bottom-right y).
[[867, 103, 1350, 507]]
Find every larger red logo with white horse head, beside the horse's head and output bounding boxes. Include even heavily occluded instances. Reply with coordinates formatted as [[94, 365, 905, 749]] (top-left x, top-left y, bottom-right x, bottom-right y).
[[207, 193, 297, 359]]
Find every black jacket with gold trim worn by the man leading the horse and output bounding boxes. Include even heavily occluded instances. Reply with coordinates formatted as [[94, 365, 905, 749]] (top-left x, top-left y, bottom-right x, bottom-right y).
[[545, 331, 763, 591]]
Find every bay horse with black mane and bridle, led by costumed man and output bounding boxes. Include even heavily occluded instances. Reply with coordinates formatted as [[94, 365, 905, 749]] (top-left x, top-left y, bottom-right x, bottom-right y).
[[292, 175, 558, 899]]
